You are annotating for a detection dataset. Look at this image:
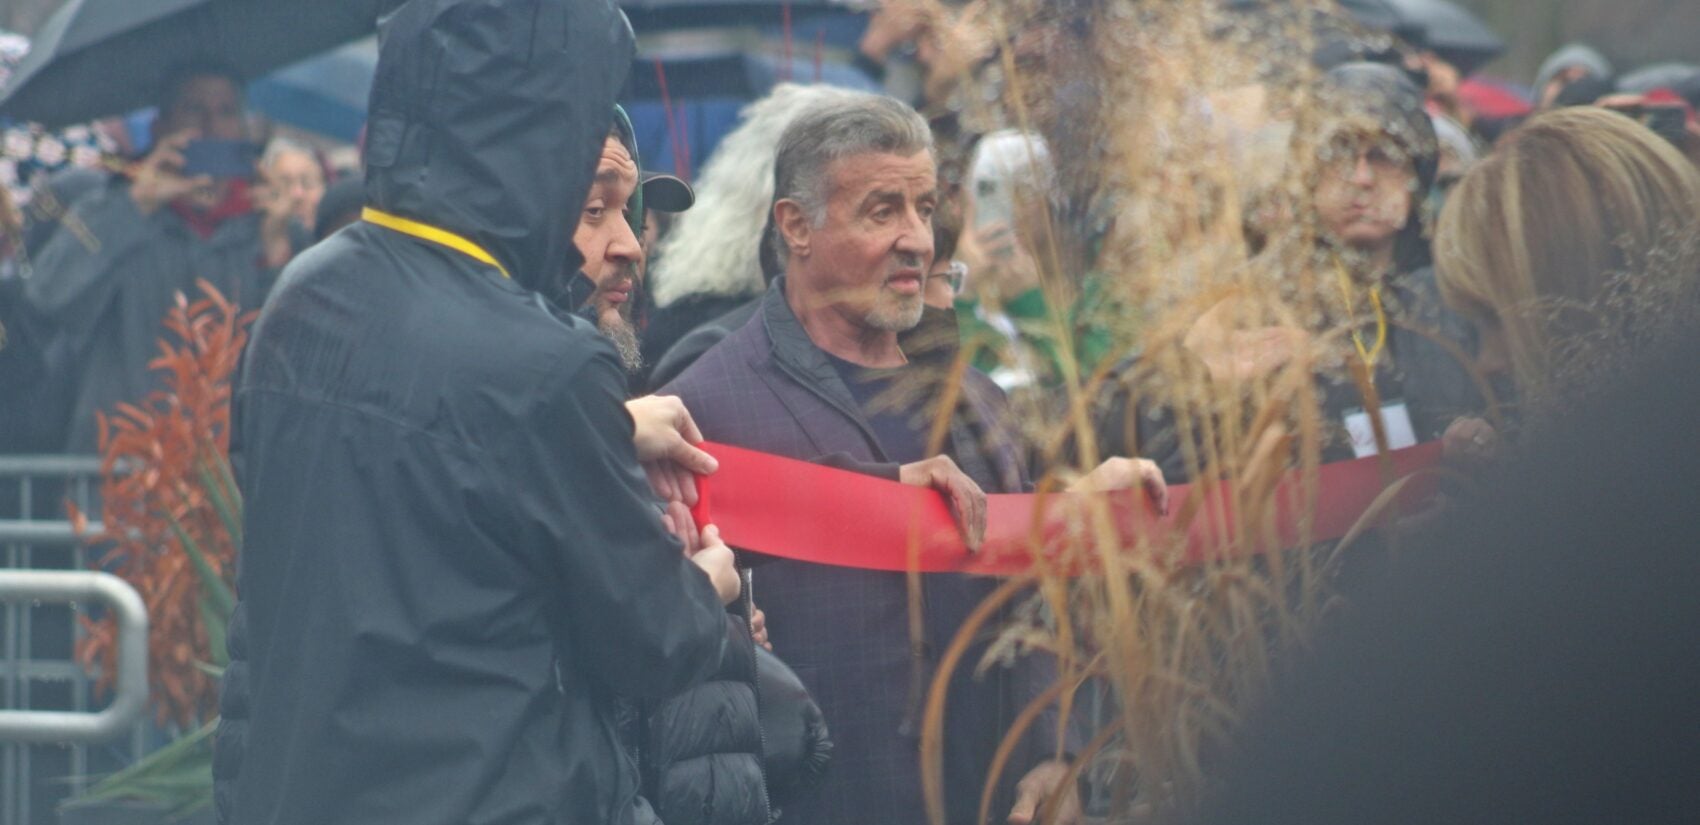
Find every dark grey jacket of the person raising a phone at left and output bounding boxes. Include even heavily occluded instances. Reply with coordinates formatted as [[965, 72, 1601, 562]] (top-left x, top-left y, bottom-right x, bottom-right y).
[[24, 175, 277, 452]]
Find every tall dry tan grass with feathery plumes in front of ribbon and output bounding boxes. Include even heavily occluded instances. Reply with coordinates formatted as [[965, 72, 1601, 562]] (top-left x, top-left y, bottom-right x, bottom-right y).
[[887, 0, 1455, 823]]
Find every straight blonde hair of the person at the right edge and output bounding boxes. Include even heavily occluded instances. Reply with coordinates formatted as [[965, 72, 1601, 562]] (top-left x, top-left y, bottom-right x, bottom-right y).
[[1435, 107, 1700, 391]]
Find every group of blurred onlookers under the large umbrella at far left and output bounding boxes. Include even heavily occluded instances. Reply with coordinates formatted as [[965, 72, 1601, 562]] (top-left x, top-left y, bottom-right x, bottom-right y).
[[0, 61, 359, 454]]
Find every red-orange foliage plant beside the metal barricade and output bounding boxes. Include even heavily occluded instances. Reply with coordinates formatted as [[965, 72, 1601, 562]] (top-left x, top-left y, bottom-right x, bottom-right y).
[[71, 281, 255, 726]]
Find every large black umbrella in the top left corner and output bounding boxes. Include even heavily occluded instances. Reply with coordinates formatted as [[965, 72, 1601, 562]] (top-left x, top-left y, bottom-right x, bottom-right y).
[[0, 0, 400, 128]]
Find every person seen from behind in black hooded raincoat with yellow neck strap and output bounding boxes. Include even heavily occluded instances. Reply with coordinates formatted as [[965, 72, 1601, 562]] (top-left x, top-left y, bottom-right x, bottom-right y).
[[214, 0, 726, 825]]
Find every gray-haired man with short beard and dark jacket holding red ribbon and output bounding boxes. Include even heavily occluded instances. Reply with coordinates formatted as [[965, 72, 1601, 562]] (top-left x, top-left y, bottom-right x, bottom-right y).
[[663, 95, 1165, 825]]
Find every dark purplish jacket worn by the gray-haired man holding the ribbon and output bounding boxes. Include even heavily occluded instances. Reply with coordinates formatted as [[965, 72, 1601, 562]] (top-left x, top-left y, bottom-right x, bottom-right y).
[[661, 277, 1054, 825]]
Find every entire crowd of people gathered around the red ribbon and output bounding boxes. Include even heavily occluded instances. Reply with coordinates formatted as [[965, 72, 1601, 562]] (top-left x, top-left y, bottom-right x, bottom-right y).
[[0, 0, 1700, 825]]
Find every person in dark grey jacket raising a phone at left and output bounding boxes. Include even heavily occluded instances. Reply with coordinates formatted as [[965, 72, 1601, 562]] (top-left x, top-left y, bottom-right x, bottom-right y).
[[26, 63, 294, 452]]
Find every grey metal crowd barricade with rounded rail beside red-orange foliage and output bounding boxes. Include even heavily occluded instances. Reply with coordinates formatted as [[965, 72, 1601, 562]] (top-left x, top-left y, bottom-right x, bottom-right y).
[[0, 456, 148, 825]]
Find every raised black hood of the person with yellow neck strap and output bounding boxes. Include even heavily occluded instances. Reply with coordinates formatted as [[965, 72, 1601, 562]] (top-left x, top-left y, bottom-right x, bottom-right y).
[[366, 0, 632, 294]]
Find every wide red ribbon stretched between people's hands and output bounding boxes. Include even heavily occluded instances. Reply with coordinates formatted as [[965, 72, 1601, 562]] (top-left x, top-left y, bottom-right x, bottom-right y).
[[692, 442, 1440, 575]]
